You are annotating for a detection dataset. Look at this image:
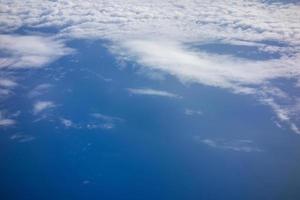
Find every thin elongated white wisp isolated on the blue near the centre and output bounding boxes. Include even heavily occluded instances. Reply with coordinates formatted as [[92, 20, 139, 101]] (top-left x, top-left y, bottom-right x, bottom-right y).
[[127, 88, 181, 98]]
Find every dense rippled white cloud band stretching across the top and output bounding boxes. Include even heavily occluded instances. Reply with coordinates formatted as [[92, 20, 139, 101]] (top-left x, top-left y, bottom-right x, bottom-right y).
[[0, 0, 300, 46]]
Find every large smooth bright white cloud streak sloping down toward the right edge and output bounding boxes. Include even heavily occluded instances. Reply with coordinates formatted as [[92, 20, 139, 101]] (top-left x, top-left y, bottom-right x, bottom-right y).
[[113, 40, 300, 93]]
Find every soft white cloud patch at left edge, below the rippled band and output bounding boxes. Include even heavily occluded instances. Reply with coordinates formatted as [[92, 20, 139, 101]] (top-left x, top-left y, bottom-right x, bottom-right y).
[[0, 34, 71, 69]]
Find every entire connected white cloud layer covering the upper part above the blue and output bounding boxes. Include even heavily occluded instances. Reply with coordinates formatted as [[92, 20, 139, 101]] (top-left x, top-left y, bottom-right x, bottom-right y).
[[0, 0, 300, 132]]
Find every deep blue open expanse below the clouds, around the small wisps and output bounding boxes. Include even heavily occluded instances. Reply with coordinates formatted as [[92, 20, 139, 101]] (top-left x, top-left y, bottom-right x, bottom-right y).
[[0, 41, 300, 200]]
